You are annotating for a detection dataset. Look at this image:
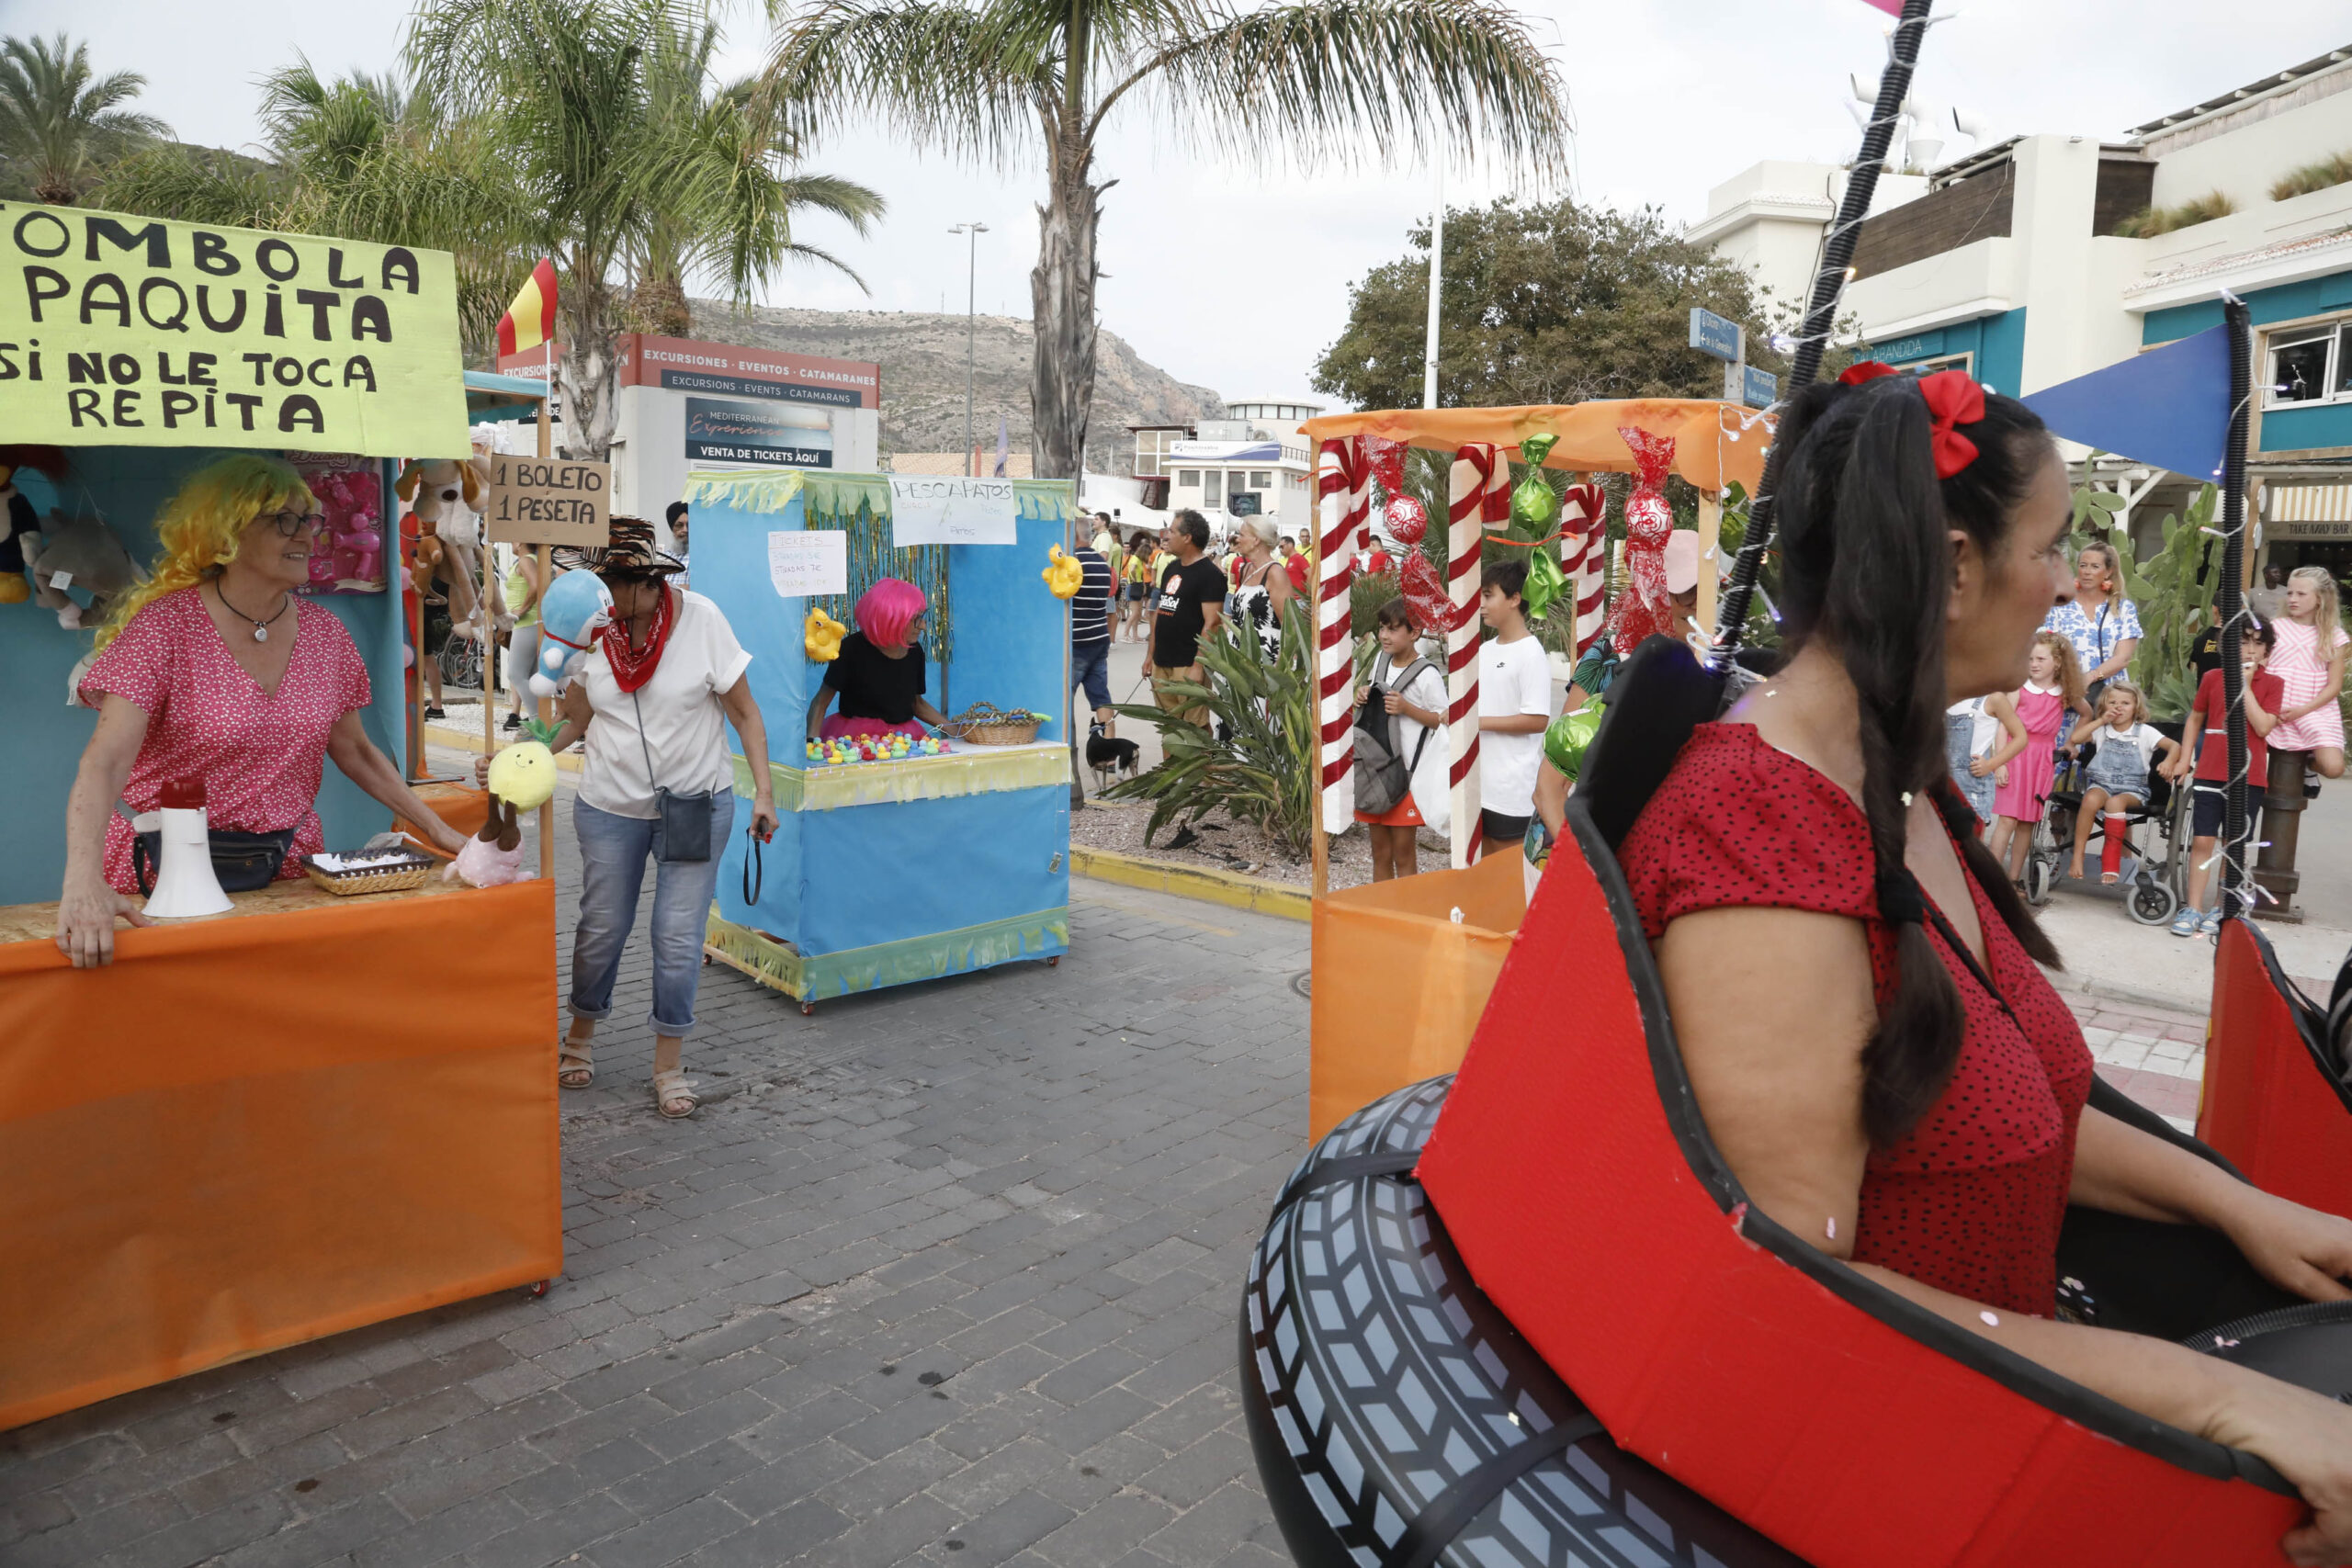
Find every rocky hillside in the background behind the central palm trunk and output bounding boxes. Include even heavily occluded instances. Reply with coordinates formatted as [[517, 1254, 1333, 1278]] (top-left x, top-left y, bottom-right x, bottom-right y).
[[694, 299, 1226, 472]]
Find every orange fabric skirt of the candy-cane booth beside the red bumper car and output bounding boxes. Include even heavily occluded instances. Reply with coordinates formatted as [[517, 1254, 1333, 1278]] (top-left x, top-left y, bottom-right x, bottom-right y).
[[1307, 853, 1526, 1138]]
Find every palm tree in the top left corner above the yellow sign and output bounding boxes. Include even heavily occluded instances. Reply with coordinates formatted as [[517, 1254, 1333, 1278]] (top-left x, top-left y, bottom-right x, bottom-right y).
[[0, 33, 172, 207]]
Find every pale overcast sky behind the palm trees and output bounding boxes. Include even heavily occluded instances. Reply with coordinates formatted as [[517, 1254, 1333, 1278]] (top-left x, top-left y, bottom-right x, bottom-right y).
[[18, 0, 2352, 400]]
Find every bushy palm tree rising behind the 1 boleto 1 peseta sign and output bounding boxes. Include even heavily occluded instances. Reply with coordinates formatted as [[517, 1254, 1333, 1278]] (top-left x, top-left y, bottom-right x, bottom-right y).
[[407, 0, 885, 458]]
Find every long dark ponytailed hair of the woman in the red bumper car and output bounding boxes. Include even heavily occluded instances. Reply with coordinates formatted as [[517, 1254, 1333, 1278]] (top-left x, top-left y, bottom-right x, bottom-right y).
[[1776, 376, 2058, 1147]]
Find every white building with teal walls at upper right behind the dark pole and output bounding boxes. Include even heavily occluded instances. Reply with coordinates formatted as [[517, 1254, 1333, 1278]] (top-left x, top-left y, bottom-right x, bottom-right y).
[[1691, 50, 2352, 576]]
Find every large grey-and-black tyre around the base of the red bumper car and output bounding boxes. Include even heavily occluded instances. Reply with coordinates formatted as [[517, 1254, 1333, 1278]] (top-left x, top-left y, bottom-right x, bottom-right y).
[[1239, 1079, 1804, 1568]]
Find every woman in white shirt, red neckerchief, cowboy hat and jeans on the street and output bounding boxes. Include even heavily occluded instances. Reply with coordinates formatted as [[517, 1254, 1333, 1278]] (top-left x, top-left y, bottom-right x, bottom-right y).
[[492, 517, 776, 1117]]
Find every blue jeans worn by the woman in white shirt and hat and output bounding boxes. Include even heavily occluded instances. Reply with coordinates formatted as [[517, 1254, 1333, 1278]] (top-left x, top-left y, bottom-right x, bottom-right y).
[[571, 790, 734, 1037]]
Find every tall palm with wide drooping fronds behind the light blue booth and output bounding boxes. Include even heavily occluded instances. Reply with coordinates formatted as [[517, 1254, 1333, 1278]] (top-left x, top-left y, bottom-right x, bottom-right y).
[[764, 0, 1569, 478]]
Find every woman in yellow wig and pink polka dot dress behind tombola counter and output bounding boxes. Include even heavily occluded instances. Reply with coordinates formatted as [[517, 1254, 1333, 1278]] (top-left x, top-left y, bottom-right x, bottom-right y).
[[56, 454, 466, 966]]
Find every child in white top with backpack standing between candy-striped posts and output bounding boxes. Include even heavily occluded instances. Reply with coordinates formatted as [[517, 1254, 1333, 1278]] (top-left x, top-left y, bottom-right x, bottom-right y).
[[1355, 600, 1446, 882]]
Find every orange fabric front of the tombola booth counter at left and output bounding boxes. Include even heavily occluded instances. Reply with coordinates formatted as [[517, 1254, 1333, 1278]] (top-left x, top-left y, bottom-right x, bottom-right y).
[[0, 879, 562, 1427]]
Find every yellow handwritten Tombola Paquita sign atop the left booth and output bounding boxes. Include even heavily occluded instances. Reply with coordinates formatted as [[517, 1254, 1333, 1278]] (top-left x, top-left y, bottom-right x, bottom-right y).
[[0, 202, 468, 458]]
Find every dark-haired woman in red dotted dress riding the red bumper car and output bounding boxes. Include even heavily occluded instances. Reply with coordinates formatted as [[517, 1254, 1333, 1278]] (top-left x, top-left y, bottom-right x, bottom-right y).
[[1618, 367, 2352, 1563]]
